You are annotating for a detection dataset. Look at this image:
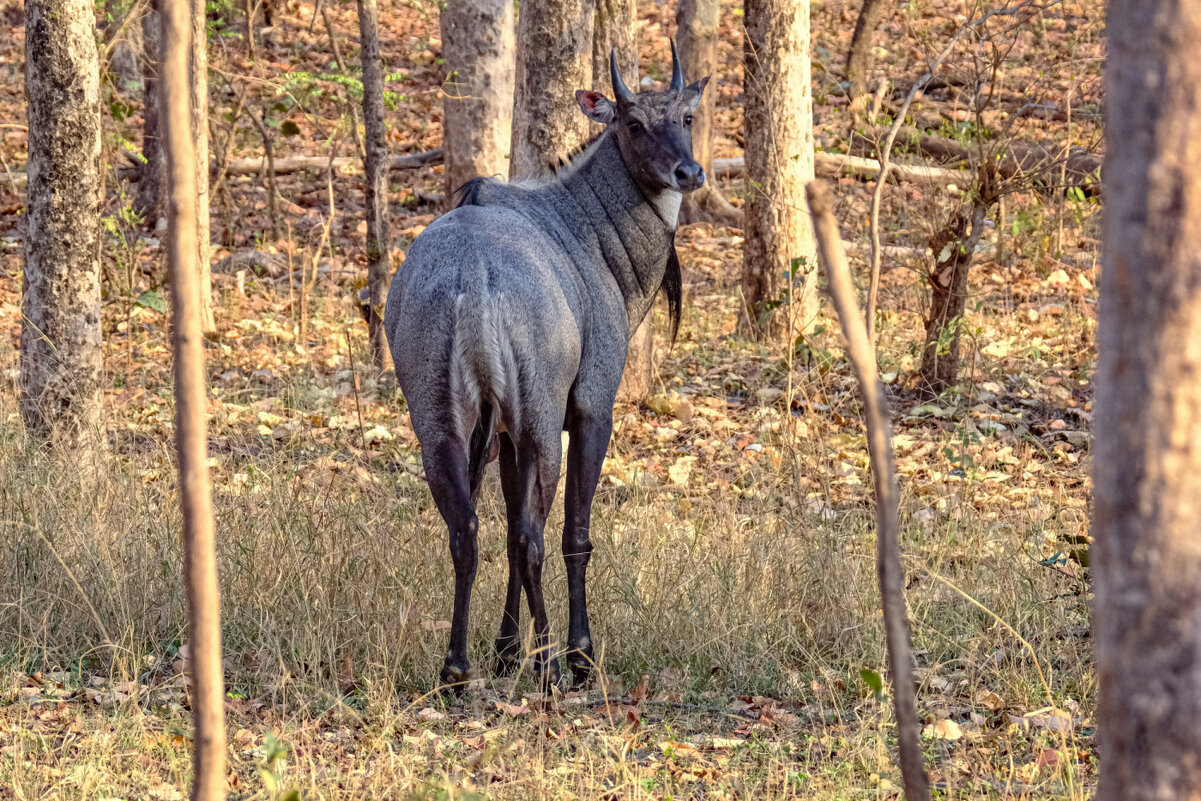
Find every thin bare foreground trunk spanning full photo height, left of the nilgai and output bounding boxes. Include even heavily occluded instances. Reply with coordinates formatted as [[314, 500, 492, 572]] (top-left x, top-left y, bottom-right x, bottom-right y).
[[162, 0, 226, 801]]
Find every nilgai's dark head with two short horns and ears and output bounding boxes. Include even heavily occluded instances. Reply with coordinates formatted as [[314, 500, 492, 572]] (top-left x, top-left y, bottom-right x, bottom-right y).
[[575, 42, 709, 192]]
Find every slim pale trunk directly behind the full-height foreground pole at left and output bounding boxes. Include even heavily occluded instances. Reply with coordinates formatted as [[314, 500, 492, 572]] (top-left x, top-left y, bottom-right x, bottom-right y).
[[187, 0, 217, 333]]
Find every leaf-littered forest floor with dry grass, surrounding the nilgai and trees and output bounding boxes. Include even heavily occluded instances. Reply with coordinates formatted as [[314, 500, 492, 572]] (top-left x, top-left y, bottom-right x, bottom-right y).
[[0, 0, 1104, 801]]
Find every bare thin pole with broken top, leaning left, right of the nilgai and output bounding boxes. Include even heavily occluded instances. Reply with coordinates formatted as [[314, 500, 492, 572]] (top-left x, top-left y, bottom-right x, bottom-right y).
[[806, 181, 930, 801]]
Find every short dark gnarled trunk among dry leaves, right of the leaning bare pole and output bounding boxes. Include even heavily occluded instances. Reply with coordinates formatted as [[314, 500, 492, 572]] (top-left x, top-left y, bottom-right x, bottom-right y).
[[920, 203, 986, 396]]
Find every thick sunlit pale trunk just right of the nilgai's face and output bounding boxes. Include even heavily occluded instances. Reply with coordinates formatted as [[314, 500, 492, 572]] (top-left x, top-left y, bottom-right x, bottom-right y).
[[741, 0, 818, 339]]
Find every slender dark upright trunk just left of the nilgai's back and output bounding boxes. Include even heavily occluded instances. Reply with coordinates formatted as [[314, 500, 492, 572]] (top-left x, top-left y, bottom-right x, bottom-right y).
[[359, 0, 392, 370]]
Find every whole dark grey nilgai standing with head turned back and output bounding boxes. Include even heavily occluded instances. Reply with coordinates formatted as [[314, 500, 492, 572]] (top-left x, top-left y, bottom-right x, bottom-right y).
[[384, 43, 709, 683]]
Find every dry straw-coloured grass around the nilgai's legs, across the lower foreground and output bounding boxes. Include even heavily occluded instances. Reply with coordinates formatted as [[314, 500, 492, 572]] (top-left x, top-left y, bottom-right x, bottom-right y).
[[0, 248, 1094, 799]]
